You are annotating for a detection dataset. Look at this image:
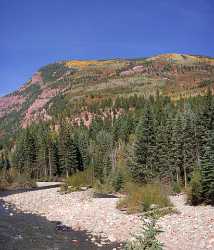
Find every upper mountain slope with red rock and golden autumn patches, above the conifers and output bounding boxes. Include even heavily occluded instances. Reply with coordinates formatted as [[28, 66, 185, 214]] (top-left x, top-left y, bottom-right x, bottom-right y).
[[0, 54, 214, 143]]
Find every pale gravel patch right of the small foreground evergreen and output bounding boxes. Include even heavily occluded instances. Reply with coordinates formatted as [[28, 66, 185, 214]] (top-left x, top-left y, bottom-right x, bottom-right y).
[[158, 195, 214, 250]]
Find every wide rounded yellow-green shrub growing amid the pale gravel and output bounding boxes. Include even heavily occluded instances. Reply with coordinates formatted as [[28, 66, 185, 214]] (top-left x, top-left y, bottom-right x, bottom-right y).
[[118, 183, 171, 213]]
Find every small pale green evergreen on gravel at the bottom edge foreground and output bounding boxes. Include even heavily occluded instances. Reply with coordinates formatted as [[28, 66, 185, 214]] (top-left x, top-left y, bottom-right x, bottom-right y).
[[124, 219, 163, 250]]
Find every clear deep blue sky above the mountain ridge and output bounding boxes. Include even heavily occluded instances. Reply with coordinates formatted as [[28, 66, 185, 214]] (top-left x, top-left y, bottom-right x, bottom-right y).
[[0, 0, 214, 96]]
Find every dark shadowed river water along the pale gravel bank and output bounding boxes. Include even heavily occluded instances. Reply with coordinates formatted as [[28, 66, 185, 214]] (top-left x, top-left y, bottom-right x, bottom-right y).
[[0, 190, 122, 250]]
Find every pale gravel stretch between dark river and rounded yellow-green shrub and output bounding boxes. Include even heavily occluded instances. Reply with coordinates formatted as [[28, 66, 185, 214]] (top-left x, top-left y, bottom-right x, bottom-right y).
[[3, 188, 141, 242]]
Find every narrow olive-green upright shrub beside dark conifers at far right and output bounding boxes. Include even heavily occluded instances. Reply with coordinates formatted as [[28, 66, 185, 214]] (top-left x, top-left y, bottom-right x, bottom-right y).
[[187, 169, 202, 205]]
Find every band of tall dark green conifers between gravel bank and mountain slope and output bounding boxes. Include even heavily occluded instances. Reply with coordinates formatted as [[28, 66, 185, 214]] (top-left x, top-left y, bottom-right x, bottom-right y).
[[0, 91, 214, 203]]
